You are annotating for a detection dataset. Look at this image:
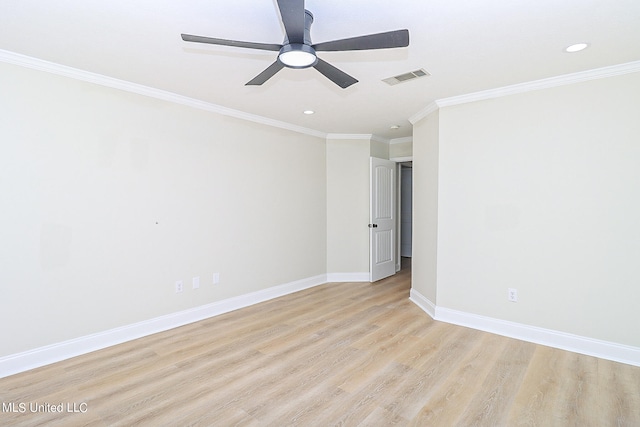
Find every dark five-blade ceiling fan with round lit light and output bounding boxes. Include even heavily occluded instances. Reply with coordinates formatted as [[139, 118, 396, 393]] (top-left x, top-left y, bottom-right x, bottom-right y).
[[182, 0, 409, 89]]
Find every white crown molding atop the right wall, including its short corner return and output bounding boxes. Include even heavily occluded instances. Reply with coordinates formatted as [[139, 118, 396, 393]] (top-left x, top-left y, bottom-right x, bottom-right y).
[[409, 61, 640, 125]]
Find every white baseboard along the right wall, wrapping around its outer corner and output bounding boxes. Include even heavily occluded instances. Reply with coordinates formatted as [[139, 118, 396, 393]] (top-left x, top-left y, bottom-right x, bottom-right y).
[[409, 289, 640, 366]]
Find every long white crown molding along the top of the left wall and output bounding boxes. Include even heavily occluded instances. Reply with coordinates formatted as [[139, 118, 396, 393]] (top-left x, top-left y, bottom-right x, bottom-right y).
[[0, 49, 327, 139]]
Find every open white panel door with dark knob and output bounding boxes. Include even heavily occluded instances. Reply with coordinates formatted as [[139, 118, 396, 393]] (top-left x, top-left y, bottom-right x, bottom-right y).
[[369, 157, 396, 282]]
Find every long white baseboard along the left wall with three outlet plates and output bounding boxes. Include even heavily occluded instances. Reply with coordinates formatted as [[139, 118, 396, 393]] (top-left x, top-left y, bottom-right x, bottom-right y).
[[0, 274, 327, 378]]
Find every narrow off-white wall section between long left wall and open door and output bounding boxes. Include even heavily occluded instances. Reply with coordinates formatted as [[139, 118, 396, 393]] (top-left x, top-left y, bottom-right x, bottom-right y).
[[327, 139, 370, 274]]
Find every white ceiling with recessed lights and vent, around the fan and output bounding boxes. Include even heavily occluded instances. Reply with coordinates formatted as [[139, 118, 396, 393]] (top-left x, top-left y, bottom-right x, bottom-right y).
[[0, 0, 640, 139]]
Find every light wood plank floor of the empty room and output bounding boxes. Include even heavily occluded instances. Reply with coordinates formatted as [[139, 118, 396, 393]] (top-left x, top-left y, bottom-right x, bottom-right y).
[[0, 262, 640, 427]]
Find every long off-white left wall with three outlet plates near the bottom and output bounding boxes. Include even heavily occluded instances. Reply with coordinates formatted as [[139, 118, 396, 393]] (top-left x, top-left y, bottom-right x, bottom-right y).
[[0, 64, 327, 356]]
